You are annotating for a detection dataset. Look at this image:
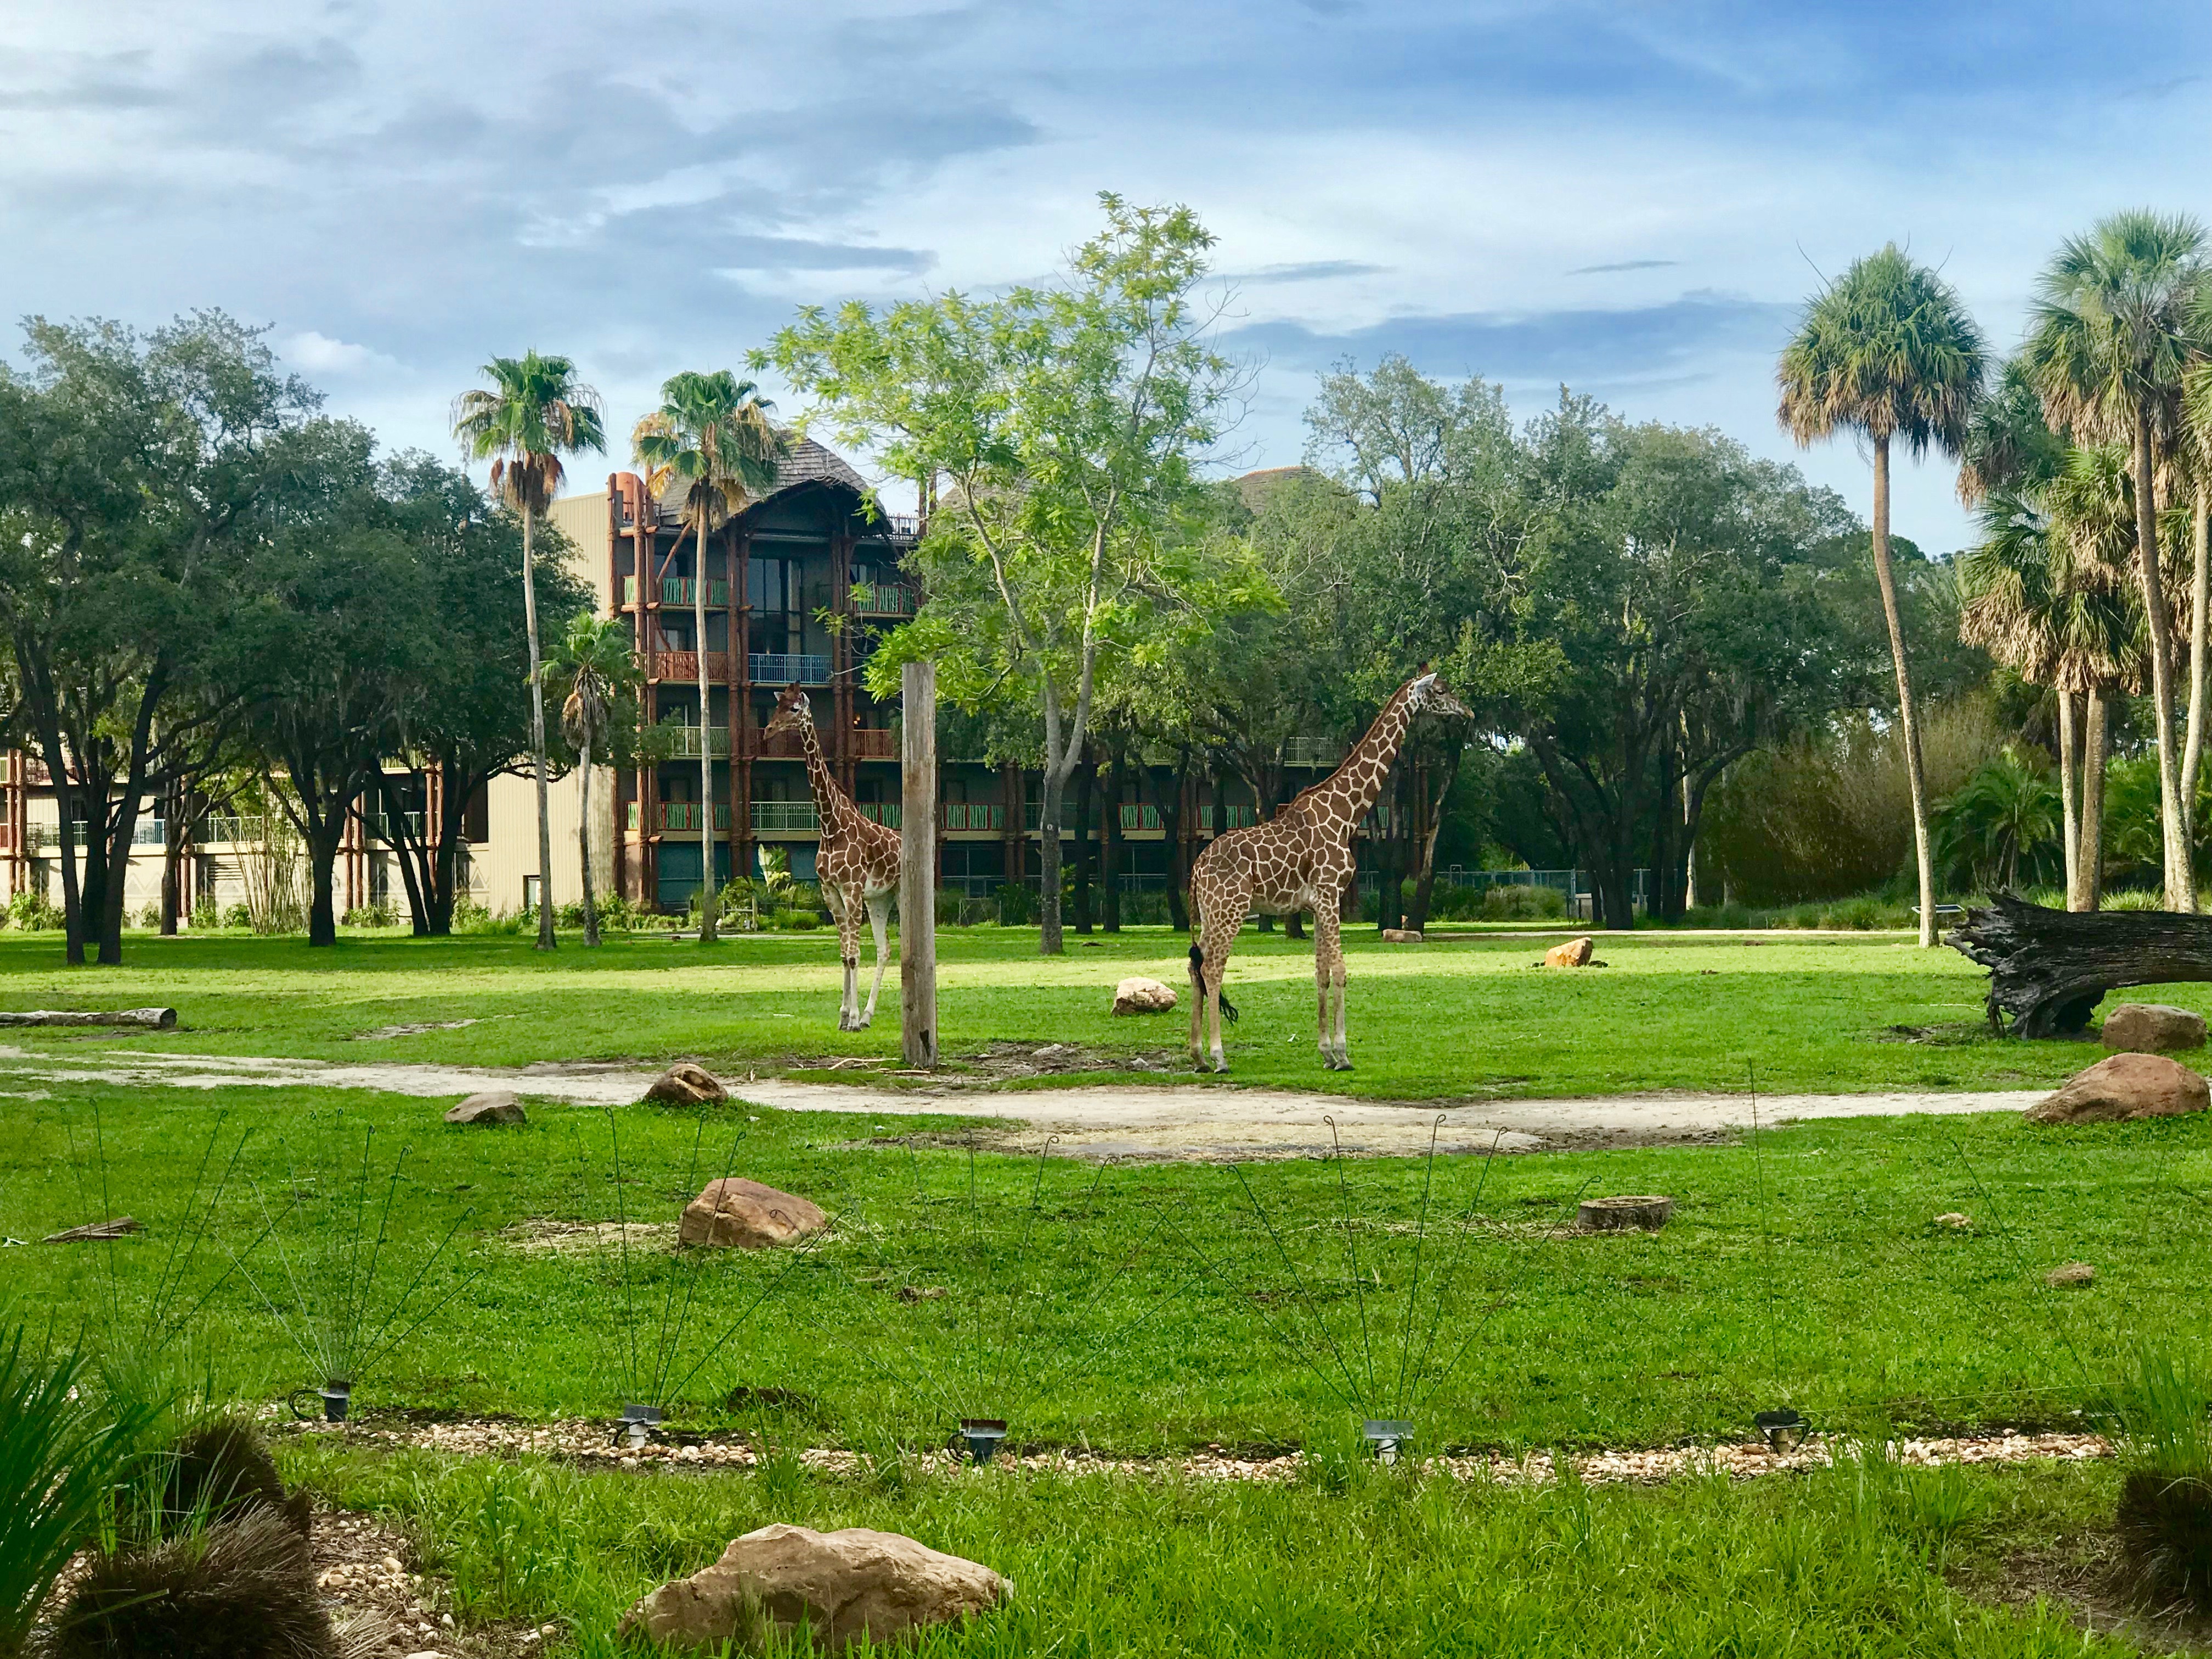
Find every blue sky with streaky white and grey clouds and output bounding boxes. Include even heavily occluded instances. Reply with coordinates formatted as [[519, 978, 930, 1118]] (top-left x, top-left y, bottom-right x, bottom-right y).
[[0, 0, 2212, 551]]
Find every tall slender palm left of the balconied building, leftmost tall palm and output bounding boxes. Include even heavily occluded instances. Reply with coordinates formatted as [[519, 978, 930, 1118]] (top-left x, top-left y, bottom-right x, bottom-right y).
[[454, 352, 606, 951]]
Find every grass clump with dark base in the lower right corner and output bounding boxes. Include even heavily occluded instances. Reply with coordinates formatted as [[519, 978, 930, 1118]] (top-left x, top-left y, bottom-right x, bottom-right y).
[[2111, 1347, 2212, 1612]]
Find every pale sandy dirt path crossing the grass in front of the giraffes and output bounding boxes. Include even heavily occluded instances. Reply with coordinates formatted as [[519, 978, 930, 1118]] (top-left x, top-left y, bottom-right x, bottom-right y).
[[0, 1044, 2044, 1159]]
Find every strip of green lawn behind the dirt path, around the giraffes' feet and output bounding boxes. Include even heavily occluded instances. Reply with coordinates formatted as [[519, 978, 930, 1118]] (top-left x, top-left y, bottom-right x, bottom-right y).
[[0, 927, 2176, 1099]]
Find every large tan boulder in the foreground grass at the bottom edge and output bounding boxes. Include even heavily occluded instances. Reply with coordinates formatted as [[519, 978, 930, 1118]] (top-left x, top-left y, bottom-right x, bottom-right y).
[[622, 1524, 1013, 1652]]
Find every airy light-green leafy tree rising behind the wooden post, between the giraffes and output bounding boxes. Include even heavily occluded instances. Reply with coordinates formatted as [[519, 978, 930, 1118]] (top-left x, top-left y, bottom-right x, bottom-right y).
[[761, 195, 1241, 956]]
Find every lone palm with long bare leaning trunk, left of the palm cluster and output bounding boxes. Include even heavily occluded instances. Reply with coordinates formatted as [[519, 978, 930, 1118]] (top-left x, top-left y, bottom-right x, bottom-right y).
[[1776, 244, 1989, 947]]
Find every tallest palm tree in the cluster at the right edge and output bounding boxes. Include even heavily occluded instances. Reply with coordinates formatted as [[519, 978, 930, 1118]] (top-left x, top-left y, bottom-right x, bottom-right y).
[[2022, 210, 2205, 911]]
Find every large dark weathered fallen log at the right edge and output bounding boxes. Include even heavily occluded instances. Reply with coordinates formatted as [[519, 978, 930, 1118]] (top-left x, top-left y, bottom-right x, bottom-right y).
[[1946, 894, 2212, 1037]]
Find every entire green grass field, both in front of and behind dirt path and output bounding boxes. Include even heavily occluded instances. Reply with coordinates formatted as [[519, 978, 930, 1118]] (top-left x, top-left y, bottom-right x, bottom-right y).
[[0, 931, 2212, 1659]]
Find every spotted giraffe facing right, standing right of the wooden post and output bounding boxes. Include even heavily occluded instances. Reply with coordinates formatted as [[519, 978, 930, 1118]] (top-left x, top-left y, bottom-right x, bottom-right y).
[[1190, 664, 1469, 1070]]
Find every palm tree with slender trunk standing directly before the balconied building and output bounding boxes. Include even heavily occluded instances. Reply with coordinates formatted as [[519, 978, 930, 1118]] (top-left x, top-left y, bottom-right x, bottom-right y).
[[630, 369, 785, 945]]
